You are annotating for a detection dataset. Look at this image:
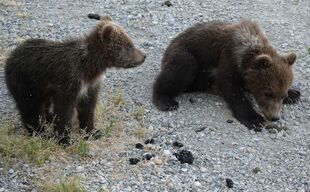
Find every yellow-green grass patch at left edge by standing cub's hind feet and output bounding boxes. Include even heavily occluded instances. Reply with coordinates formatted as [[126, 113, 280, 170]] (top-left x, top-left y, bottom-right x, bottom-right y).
[[0, 123, 61, 165]]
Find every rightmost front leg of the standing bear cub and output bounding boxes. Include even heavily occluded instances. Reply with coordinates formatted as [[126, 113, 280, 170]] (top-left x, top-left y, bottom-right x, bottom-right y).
[[77, 87, 101, 139]]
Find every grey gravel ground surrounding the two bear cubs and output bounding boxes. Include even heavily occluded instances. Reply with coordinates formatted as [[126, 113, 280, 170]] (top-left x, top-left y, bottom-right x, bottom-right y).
[[0, 0, 310, 192]]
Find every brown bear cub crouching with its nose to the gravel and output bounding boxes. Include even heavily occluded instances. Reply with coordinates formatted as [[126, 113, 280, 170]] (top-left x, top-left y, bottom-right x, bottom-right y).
[[153, 21, 300, 130]]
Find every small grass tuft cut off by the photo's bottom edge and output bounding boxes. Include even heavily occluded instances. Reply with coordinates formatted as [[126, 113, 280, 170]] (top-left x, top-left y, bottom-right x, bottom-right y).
[[42, 177, 86, 192]]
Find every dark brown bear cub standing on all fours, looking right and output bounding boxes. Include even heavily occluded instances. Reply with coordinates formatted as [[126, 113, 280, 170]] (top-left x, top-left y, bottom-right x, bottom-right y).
[[5, 14, 146, 144]]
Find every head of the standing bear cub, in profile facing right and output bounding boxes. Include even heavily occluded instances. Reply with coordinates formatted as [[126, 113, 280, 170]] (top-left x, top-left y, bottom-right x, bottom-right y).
[[89, 16, 146, 68]]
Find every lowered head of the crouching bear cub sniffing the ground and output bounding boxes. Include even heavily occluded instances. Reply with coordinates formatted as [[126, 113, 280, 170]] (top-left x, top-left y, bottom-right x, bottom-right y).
[[244, 53, 297, 121]]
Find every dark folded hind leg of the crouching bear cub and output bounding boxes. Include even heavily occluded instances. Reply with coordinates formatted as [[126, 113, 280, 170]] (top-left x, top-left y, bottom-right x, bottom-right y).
[[153, 51, 198, 111]]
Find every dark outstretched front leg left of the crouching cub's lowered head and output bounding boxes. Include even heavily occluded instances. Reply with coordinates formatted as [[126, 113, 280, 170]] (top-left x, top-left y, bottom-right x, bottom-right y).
[[217, 72, 265, 131]]
